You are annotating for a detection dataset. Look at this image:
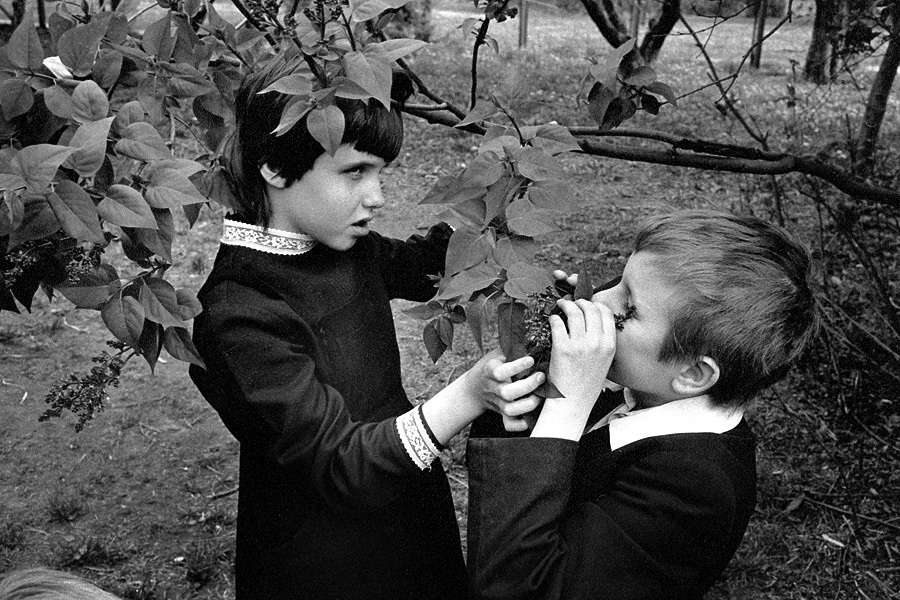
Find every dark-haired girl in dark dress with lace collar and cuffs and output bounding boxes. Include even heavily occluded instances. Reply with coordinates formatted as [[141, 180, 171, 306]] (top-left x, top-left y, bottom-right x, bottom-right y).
[[190, 57, 539, 600]]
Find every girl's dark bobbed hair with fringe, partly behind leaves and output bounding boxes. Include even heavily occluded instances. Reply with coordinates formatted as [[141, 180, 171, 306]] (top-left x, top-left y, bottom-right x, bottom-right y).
[[226, 54, 413, 227]]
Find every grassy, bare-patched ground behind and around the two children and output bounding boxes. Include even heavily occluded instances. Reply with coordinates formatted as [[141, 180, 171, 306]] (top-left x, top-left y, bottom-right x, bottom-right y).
[[0, 3, 900, 599]]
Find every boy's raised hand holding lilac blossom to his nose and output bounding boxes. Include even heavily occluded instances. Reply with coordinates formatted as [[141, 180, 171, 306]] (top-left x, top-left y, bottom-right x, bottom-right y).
[[549, 300, 616, 406]]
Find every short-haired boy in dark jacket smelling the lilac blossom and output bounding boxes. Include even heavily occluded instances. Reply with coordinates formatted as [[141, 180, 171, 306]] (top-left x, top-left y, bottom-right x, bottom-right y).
[[467, 211, 817, 600]]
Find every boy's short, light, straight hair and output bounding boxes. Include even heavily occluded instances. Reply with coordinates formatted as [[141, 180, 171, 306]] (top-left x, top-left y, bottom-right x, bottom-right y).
[[634, 210, 818, 405]]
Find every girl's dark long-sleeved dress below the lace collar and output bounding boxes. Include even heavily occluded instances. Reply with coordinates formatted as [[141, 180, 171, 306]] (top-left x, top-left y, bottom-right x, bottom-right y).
[[191, 225, 466, 600]]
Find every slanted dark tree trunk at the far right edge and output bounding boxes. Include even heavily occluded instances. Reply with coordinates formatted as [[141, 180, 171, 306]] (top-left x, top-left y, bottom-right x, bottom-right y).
[[853, 23, 900, 177]]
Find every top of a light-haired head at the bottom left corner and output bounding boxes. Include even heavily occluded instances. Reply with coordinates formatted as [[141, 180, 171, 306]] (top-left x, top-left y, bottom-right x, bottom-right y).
[[0, 568, 121, 600]]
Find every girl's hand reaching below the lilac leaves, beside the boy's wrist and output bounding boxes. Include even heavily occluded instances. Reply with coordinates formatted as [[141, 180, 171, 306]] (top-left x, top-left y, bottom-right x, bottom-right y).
[[473, 350, 545, 431]]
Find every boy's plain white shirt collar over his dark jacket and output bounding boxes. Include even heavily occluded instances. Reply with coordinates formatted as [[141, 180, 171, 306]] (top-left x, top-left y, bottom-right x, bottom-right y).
[[592, 388, 744, 450]]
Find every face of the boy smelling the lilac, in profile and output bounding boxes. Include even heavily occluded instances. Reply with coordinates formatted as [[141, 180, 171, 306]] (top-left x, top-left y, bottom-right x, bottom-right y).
[[592, 252, 679, 408]]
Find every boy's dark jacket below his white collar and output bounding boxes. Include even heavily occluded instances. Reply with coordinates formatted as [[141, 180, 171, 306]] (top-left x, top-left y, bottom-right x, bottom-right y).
[[467, 392, 756, 600]]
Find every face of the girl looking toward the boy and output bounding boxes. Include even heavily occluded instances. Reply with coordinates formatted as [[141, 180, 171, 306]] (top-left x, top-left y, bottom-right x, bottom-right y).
[[269, 144, 385, 250]]
